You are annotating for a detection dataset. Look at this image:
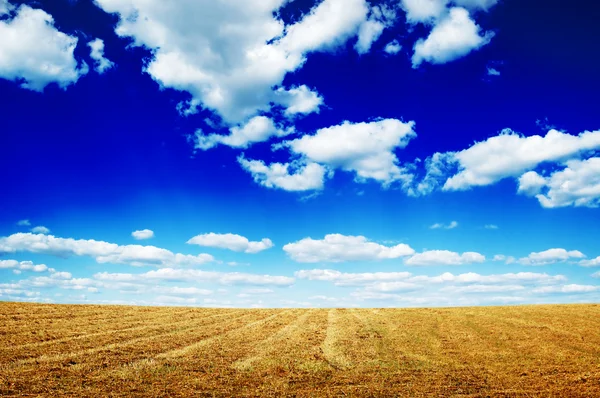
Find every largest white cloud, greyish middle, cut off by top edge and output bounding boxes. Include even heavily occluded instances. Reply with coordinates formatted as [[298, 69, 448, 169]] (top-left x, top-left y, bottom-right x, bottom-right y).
[[96, 0, 369, 124]]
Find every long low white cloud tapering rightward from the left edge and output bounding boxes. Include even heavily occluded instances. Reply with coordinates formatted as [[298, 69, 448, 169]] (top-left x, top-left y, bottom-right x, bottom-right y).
[[0, 233, 214, 267]]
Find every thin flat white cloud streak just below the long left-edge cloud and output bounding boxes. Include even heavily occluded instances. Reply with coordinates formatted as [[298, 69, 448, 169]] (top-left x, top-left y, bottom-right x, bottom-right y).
[[94, 268, 294, 286]]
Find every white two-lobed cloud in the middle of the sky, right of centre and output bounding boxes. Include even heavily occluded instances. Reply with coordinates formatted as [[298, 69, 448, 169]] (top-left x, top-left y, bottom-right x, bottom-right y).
[[239, 119, 416, 191]]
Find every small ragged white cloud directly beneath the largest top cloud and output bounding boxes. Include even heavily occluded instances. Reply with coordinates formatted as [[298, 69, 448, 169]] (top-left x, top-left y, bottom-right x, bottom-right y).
[[194, 116, 293, 151]]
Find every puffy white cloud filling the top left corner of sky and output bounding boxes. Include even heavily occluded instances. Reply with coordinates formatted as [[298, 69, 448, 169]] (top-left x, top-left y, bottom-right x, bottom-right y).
[[0, 2, 88, 91]]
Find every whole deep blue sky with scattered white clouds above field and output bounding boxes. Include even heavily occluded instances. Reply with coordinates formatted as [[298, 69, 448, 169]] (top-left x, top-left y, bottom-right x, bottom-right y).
[[0, 0, 600, 307]]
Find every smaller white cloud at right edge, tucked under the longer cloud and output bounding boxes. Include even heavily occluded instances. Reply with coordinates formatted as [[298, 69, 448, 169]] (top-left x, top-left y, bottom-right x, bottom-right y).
[[536, 157, 600, 208]]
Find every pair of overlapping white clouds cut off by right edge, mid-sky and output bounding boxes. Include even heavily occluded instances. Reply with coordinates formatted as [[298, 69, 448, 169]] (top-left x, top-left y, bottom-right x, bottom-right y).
[[408, 129, 600, 208]]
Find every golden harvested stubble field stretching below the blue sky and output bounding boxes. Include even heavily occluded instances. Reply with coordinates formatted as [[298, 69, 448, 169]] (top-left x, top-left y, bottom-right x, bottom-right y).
[[0, 303, 600, 397]]
